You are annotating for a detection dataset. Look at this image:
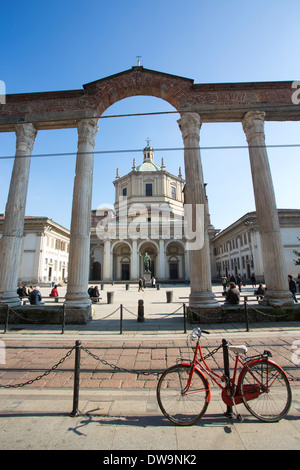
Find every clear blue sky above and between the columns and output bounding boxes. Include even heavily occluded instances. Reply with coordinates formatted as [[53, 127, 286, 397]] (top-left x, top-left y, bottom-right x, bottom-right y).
[[0, 0, 300, 229]]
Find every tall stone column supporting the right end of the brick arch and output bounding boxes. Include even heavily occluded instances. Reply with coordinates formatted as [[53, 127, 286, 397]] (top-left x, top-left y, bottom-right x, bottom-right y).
[[178, 113, 220, 309]]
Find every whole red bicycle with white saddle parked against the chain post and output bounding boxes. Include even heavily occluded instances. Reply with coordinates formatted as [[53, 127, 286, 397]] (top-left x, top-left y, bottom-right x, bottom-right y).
[[157, 328, 292, 426]]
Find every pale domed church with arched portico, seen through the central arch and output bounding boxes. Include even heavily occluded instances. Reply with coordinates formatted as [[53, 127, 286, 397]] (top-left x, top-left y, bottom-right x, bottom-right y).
[[90, 142, 190, 281]]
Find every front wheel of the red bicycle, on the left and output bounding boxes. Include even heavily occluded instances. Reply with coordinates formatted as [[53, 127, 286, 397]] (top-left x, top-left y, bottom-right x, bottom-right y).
[[156, 364, 209, 426]]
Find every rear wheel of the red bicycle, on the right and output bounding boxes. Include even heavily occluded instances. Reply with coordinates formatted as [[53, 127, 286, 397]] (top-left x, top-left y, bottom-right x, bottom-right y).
[[241, 360, 292, 423]]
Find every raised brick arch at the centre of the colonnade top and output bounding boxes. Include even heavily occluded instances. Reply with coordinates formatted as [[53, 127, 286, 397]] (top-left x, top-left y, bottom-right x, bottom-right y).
[[84, 67, 193, 115]]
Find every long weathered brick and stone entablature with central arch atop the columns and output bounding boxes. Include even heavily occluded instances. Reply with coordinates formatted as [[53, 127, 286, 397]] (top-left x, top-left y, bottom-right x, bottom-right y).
[[0, 67, 300, 132]]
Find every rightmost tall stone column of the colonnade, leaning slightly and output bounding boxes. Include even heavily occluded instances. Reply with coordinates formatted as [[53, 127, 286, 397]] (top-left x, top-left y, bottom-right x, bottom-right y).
[[242, 111, 293, 306]]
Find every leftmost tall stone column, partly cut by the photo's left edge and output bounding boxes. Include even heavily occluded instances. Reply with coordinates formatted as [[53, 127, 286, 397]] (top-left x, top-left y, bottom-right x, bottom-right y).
[[0, 123, 37, 305]]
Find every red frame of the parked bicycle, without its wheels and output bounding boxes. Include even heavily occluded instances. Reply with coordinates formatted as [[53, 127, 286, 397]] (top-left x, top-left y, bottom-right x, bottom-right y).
[[181, 337, 282, 406]]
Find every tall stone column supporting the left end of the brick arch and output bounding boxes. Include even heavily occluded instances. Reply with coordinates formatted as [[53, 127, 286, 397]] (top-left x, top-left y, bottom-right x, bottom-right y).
[[65, 118, 98, 308]]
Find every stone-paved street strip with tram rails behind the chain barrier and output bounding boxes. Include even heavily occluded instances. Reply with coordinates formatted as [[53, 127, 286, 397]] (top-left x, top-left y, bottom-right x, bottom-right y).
[[0, 332, 300, 389]]
